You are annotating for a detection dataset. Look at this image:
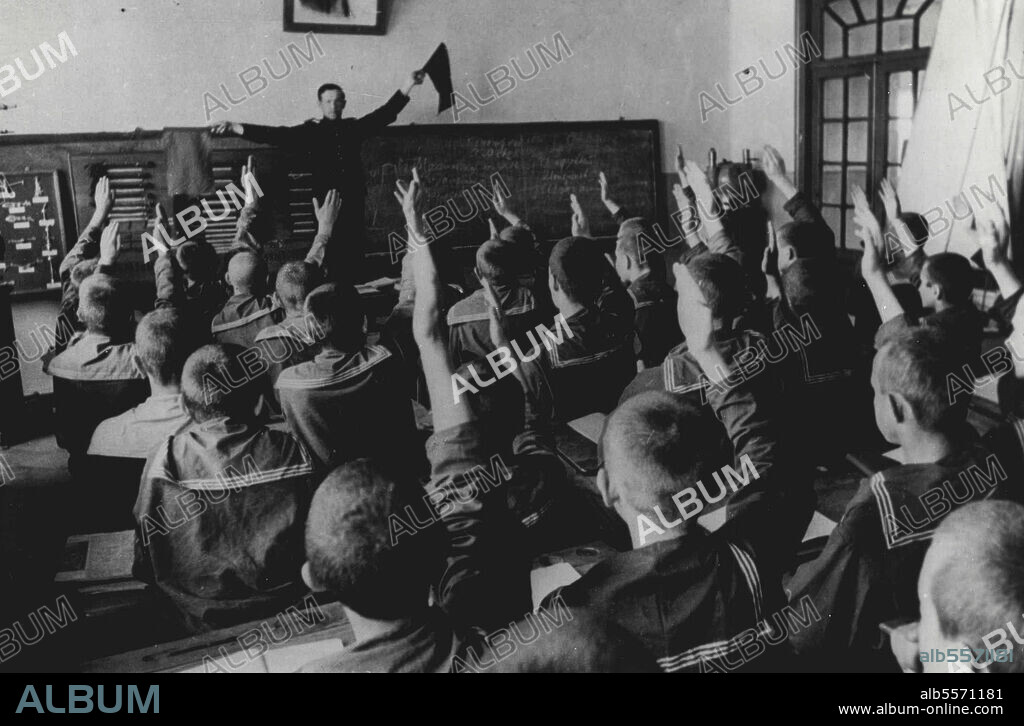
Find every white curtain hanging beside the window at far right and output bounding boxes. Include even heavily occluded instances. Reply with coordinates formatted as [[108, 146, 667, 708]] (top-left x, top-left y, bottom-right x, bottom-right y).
[[899, 0, 1024, 260]]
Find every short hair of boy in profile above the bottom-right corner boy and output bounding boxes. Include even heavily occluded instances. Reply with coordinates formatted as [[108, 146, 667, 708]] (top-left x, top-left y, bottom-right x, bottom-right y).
[[874, 328, 966, 431]]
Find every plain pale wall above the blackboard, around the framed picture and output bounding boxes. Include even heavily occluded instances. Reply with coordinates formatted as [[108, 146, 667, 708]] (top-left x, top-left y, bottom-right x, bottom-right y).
[[0, 0, 753, 170]]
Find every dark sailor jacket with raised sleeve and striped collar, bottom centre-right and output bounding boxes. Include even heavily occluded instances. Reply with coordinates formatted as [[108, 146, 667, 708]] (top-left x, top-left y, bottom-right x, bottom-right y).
[[549, 362, 803, 673]]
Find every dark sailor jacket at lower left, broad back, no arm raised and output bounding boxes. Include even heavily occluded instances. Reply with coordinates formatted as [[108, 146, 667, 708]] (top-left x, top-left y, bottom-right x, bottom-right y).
[[134, 418, 317, 630]]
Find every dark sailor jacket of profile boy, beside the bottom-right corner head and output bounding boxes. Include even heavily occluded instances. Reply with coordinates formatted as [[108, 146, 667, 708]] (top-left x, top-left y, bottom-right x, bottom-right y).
[[788, 439, 1020, 670]]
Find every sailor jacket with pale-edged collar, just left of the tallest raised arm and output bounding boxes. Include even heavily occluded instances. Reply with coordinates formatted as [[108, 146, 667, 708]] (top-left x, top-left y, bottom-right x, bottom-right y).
[[275, 345, 422, 468]]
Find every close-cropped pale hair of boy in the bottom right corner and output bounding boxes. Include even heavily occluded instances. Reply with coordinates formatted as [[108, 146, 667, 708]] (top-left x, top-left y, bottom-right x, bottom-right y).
[[931, 501, 1024, 673]]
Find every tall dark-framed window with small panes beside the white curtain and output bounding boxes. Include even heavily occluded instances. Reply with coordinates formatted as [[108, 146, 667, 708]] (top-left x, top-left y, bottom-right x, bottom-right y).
[[800, 0, 942, 249]]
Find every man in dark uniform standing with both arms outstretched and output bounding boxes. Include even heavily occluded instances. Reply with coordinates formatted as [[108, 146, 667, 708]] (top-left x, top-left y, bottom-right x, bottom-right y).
[[210, 71, 424, 283]]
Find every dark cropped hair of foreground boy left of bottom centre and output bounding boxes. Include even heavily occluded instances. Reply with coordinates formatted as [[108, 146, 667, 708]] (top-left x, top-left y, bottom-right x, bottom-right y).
[[306, 459, 443, 621]]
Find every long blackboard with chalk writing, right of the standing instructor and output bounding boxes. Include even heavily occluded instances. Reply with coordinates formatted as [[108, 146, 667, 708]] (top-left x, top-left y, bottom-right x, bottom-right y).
[[362, 121, 664, 254]]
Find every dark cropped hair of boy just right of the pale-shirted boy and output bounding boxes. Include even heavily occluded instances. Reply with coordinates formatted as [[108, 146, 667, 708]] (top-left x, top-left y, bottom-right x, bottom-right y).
[[181, 345, 258, 423]]
